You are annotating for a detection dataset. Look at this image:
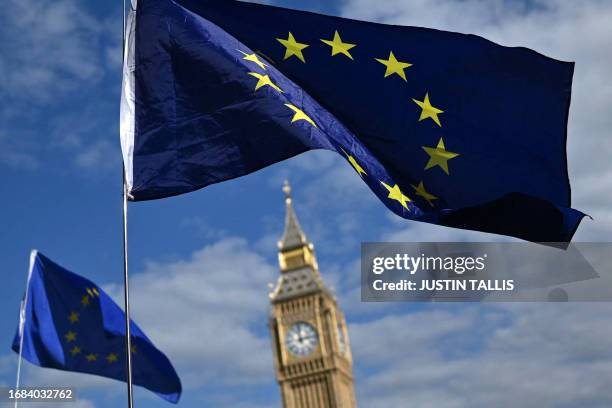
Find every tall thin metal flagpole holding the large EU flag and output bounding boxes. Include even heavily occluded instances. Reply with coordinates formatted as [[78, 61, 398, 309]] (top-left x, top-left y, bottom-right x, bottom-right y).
[[121, 0, 134, 408]]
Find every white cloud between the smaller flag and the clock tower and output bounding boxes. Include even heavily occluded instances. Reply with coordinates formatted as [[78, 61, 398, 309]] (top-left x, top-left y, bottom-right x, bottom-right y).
[[106, 238, 278, 388]]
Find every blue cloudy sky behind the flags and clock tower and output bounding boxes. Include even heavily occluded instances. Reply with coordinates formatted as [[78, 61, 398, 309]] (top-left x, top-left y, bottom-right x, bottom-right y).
[[0, 0, 612, 408]]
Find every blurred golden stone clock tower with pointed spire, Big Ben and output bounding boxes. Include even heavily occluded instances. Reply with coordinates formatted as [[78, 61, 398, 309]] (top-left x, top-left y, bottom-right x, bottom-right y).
[[269, 182, 356, 408]]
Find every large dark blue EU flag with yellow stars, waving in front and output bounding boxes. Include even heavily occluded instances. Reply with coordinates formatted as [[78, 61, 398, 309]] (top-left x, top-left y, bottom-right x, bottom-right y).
[[121, 0, 583, 242]]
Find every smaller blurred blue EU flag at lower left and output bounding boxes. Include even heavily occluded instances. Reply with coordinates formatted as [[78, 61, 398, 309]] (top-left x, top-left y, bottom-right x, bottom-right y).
[[13, 251, 181, 403]]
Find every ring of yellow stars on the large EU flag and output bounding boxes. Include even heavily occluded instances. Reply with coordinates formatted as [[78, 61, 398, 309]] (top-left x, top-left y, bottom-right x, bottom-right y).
[[237, 30, 460, 211]]
